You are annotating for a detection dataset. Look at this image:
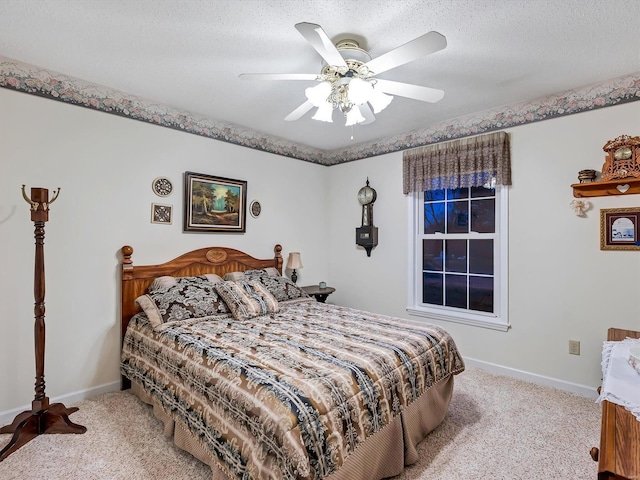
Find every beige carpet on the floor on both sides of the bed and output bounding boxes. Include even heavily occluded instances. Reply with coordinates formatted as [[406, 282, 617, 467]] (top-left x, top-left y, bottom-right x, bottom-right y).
[[0, 368, 600, 480]]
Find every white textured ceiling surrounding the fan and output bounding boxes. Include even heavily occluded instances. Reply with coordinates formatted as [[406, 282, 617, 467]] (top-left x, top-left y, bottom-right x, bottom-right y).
[[0, 0, 640, 154]]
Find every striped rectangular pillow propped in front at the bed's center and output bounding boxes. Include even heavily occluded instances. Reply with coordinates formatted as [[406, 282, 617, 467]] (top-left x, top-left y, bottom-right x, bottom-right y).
[[215, 280, 280, 320]]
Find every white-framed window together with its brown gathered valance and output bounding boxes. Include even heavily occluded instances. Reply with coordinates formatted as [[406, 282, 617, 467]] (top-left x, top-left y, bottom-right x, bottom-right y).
[[403, 132, 511, 331]]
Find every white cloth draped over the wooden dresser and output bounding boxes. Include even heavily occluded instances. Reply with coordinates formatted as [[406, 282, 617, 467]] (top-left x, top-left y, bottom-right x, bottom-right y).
[[598, 338, 640, 420]]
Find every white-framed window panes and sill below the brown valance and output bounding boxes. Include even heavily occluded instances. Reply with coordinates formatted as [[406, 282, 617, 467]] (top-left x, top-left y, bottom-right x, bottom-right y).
[[408, 186, 508, 330]]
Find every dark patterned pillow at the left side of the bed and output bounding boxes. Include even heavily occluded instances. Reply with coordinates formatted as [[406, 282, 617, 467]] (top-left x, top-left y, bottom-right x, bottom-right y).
[[136, 275, 229, 328]]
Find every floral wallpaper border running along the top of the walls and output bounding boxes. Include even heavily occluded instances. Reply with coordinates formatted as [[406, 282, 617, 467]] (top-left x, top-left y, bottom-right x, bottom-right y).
[[0, 56, 640, 165]]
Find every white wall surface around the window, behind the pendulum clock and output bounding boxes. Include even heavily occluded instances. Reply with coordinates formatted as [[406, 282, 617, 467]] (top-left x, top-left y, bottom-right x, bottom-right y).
[[329, 102, 640, 388]]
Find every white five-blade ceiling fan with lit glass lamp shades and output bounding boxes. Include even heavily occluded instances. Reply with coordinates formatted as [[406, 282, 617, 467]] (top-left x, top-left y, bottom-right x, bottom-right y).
[[240, 22, 447, 126]]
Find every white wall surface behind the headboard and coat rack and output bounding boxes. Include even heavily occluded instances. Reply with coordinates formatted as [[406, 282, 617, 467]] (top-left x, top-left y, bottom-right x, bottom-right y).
[[0, 89, 329, 417]]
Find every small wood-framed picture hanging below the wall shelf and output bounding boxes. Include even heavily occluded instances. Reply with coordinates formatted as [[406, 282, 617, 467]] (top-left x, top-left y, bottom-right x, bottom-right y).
[[600, 207, 640, 250]]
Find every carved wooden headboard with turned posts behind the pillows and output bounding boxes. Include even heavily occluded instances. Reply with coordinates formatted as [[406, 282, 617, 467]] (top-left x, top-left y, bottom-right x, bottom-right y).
[[120, 245, 282, 348]]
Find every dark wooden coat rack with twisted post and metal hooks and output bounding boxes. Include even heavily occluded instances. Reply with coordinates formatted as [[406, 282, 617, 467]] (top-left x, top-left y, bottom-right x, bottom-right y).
[[0, 185, 87, 462]]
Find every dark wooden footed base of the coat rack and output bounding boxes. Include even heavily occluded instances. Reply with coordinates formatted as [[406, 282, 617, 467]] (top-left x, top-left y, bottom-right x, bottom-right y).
[[0, 398, 87, 462]]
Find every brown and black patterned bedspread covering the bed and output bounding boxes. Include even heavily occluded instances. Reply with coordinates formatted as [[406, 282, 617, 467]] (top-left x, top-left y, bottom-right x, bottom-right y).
[[121, 300, 464, 479]]
